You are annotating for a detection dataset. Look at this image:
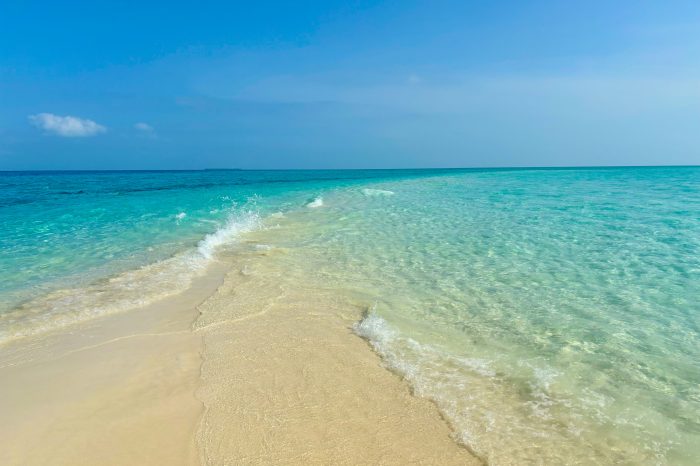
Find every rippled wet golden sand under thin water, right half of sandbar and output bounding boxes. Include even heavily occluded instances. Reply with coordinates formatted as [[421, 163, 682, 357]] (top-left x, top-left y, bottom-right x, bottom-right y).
[[196, 246, 478, 465]]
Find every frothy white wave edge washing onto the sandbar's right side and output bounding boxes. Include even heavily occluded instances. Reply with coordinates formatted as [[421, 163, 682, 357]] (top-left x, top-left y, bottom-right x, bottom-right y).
[[353, 305, 592, 464]]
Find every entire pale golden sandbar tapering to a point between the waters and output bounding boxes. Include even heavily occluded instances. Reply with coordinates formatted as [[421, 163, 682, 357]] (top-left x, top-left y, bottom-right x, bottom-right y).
[[0, 238, 479, 465]]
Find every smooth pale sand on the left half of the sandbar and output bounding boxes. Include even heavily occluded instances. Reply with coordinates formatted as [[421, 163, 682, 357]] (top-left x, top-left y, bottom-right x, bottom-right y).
[[0, 270, 218, 465]]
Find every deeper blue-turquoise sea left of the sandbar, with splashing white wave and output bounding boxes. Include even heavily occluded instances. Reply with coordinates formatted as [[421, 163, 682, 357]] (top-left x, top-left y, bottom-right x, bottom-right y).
[[0, 171, 416, 336]]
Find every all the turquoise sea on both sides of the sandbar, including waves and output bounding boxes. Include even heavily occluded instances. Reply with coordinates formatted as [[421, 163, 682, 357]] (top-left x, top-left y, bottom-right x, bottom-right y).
[[0, 167, 700, 464]]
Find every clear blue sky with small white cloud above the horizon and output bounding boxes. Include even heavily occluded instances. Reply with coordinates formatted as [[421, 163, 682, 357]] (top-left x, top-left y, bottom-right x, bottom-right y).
[[0, 0, 700, 170]]
